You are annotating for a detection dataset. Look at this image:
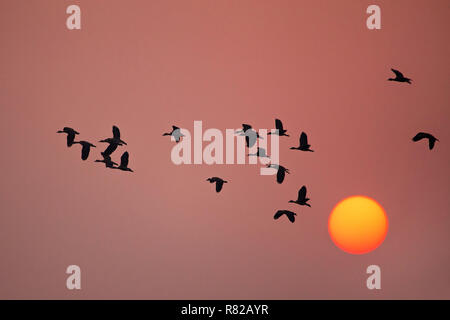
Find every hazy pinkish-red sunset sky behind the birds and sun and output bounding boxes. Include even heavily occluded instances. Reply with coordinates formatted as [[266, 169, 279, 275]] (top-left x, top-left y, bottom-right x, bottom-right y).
[[0, 0, 450, 299]]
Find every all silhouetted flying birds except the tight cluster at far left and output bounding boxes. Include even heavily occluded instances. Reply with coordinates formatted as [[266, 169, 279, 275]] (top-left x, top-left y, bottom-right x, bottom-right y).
[[163, 69, 439, 223]]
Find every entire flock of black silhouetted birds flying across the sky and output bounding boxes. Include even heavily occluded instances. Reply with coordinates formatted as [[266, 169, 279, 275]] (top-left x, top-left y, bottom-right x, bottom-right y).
[[57, 69, 439, 223]]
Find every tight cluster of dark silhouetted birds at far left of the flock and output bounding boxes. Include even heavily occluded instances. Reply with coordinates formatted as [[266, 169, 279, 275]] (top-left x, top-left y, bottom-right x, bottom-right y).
[[57, 126, 133, 172]]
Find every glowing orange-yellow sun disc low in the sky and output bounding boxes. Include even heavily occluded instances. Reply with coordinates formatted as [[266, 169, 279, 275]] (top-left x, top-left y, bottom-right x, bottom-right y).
[[328, 196, 388, 254]]
